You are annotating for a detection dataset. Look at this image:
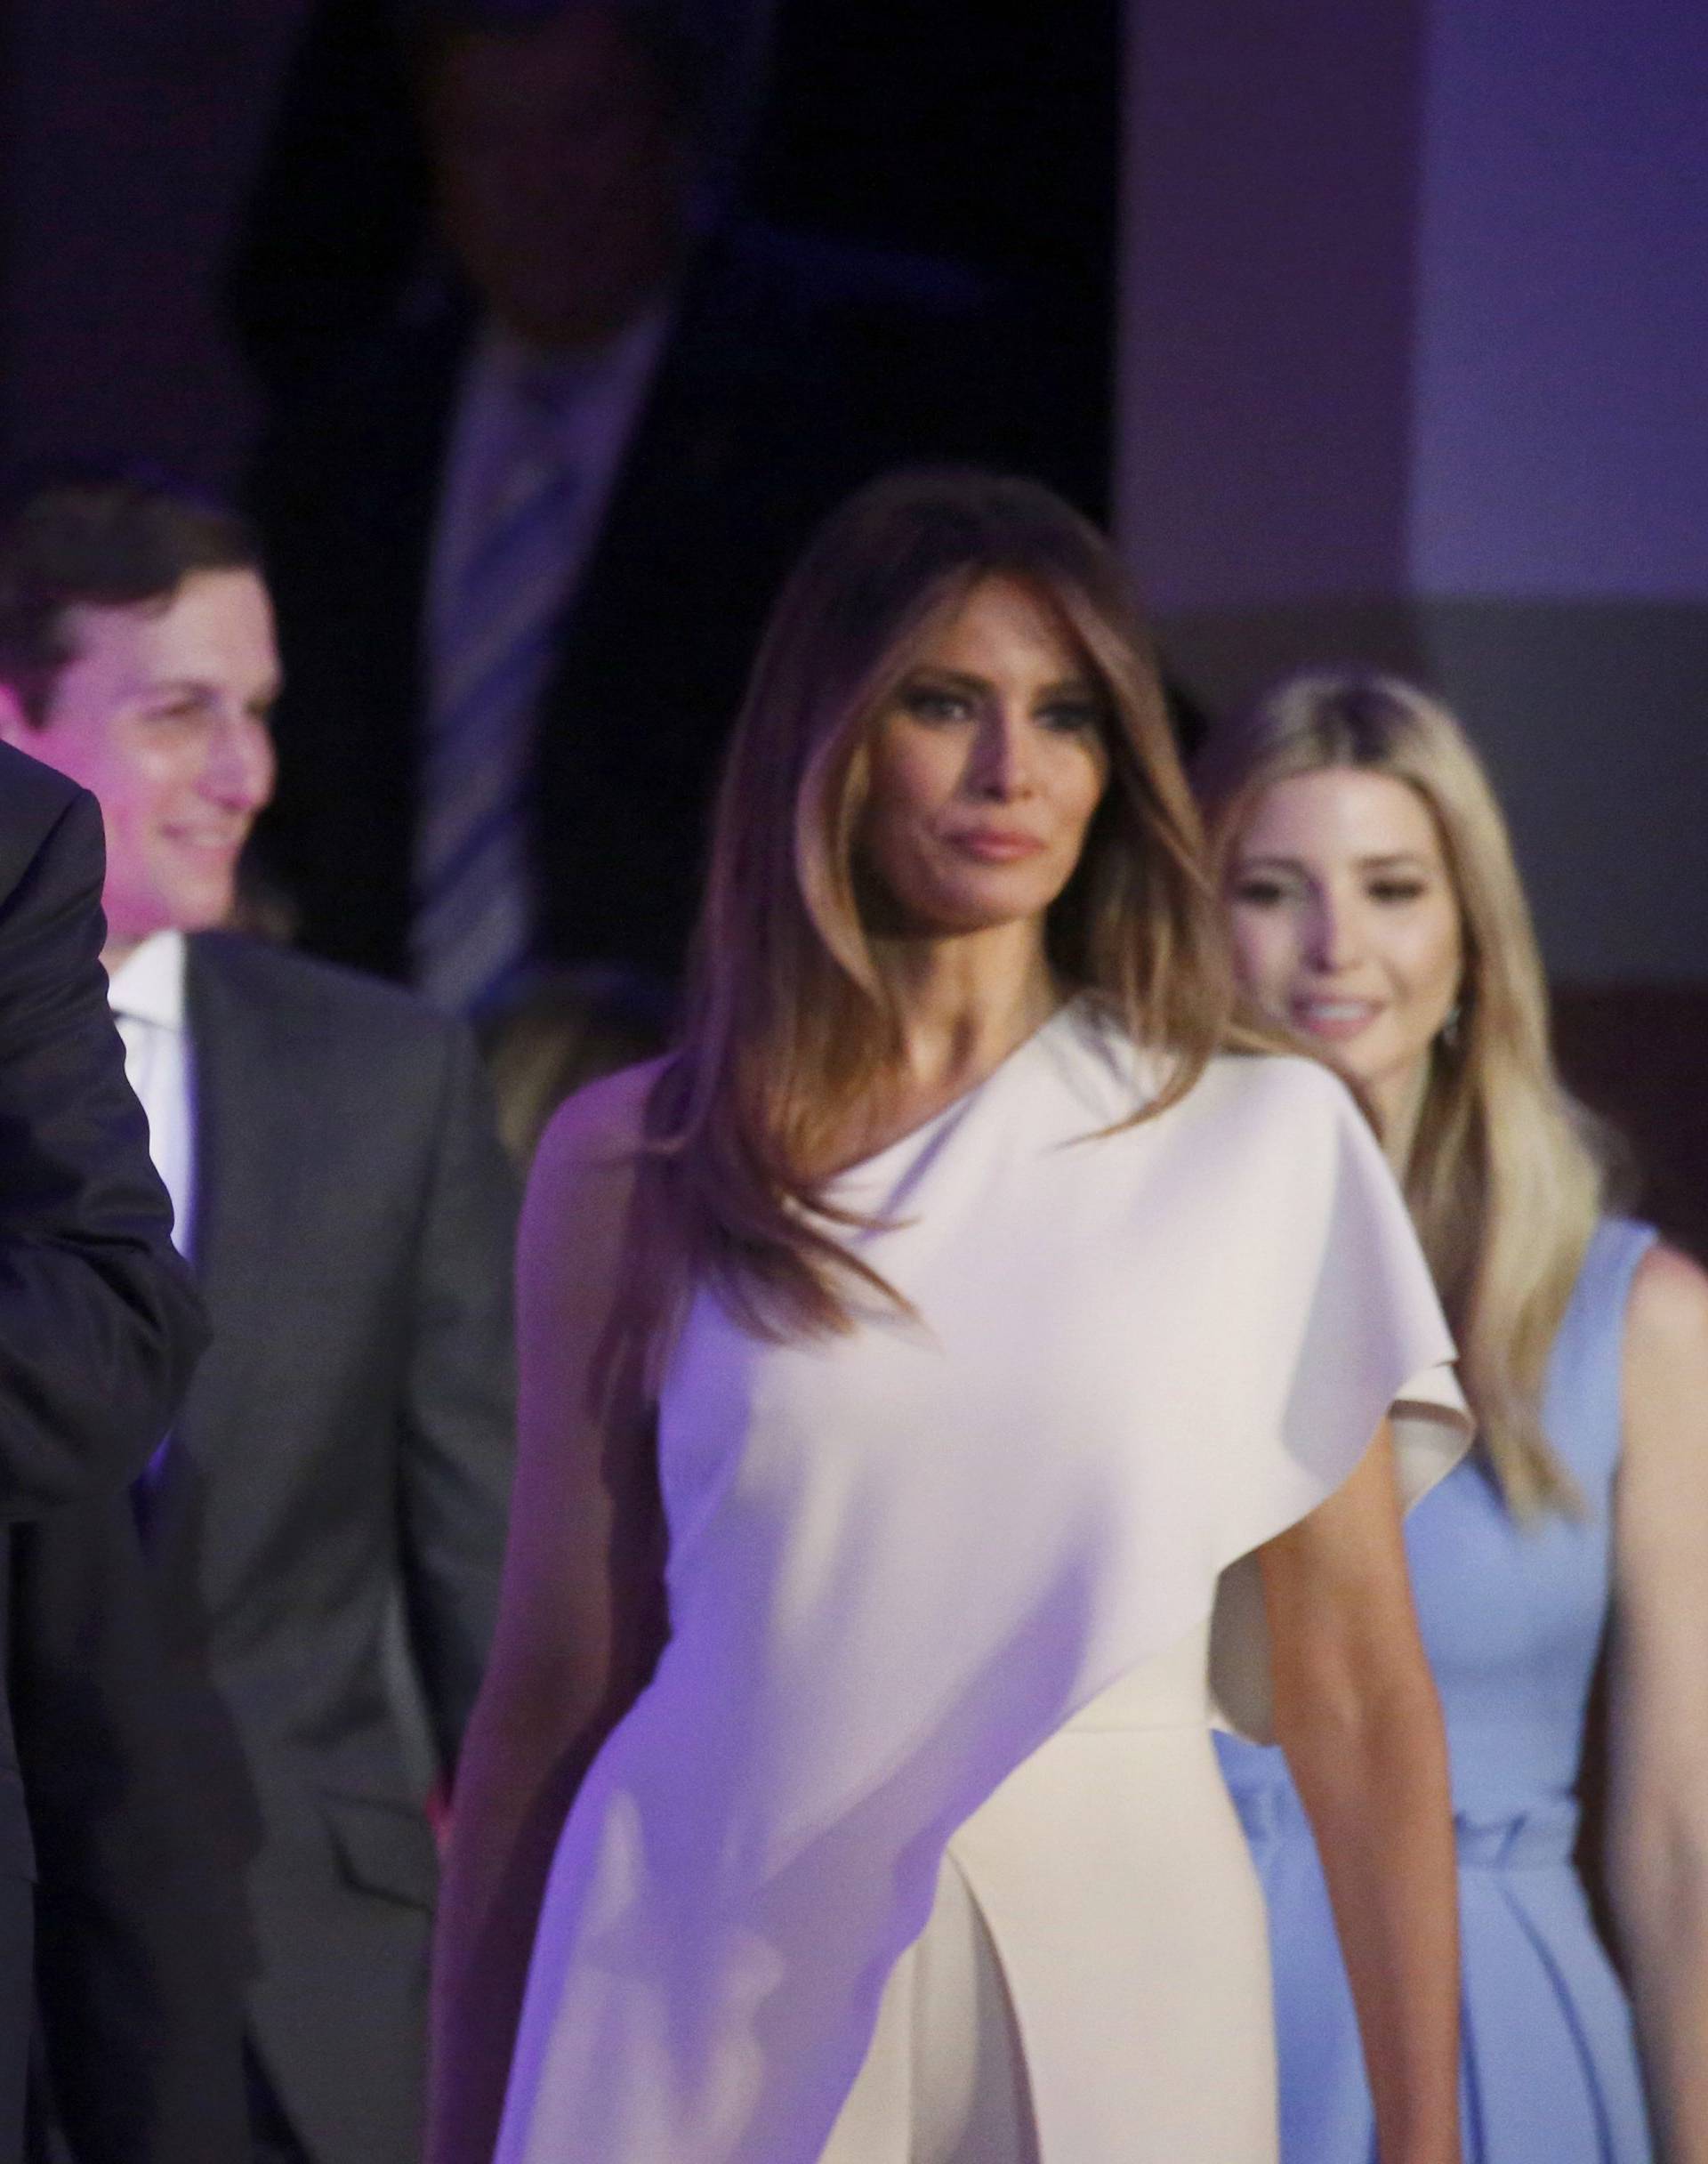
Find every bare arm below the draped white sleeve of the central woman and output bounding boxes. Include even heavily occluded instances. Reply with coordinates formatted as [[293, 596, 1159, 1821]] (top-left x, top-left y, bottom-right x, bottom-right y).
[[1260, 1426, 1462, 2164]]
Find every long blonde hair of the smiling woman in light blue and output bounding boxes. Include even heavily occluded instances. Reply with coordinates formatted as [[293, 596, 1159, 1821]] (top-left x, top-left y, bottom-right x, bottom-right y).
[[1195, 671, 1604, 1517]]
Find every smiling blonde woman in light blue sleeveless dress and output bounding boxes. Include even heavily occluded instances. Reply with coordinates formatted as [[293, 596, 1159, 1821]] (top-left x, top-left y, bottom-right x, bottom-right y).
[[1199, 673, 1708, 2164]]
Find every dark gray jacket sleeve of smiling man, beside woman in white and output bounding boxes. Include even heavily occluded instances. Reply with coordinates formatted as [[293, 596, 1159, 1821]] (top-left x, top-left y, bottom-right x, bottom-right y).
[[400, 1030, 518, 1766]]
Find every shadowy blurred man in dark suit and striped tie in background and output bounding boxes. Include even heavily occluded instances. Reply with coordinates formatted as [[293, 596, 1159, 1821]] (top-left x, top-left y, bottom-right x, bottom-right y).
[[254, 0, 1073, 1013]]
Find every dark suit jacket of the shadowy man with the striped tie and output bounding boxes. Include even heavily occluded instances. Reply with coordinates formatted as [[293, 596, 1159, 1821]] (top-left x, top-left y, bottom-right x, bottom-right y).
[[251, 225, 1073, 976]]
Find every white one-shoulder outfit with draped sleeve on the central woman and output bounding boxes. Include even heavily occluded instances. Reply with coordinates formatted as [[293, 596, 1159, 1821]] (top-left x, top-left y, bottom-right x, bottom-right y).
[[498, 997, 1465, 2164]]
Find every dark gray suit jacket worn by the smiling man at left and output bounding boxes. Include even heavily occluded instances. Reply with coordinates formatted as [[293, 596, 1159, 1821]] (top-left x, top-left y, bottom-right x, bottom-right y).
[[149, 933, 513, 2164]]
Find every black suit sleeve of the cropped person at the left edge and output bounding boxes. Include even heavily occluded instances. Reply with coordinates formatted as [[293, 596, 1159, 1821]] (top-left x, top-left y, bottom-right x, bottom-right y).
[[0, 792, 204, 1517]]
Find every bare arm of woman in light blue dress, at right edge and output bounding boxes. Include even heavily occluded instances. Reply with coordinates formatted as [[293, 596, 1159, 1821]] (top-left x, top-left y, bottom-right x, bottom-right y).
[[1608, 1248, 1708, 2164]]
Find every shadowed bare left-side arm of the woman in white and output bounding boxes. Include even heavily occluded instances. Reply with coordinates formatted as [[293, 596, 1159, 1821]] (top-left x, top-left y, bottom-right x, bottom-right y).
[[426, 1069, 665, 2164]]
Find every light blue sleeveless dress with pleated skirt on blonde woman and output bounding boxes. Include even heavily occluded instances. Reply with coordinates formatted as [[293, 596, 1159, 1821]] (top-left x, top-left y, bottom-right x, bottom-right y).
[[1217, 1218, 1656, 2164]]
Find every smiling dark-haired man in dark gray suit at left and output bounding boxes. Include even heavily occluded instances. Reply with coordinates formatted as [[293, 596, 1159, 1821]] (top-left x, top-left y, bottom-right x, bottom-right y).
[[0, 480, 513, 2164]]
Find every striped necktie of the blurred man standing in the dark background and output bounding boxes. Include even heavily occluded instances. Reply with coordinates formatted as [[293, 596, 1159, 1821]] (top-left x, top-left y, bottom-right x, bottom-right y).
[[411, 383, 580, 1013]]
